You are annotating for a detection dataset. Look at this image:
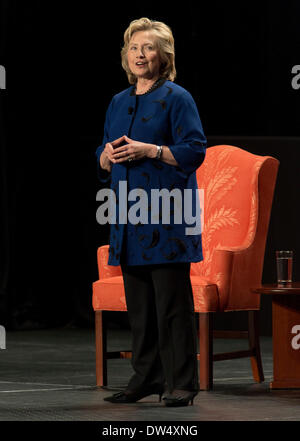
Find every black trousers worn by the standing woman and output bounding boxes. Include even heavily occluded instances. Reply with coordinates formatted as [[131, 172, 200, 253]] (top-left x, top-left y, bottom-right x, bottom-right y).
[[121, 263, 199, 391]]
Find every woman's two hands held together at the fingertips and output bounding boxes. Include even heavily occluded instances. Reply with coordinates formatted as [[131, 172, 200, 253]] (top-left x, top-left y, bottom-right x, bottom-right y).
[[103, 135, 156, 168]]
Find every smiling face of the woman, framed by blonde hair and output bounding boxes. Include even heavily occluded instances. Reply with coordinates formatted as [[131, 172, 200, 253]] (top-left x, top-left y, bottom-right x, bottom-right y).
[[127, 31, 160, 79]]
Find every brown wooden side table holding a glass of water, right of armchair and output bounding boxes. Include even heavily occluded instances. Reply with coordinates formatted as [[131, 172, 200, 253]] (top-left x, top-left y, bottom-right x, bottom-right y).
[[252, 282, 300, 389]]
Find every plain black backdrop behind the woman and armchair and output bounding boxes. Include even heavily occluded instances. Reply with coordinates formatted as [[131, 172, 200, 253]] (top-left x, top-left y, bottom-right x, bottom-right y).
[[0, 0, 300, 334]]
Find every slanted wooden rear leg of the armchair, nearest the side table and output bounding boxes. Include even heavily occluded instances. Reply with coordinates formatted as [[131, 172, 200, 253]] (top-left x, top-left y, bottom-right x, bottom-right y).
[[248, 311, 264, 383]]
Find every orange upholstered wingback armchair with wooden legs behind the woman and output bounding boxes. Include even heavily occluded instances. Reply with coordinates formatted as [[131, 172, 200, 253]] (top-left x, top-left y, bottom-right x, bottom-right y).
[[93, 145, 279, 390]]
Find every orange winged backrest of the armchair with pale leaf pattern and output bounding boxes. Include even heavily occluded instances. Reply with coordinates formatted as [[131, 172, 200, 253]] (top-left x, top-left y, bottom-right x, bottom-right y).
[[191, 145, 279, 310]]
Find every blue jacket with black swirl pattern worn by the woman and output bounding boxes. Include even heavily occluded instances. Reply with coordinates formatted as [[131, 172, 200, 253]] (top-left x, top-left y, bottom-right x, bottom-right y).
[[96, 81, 206, 266]]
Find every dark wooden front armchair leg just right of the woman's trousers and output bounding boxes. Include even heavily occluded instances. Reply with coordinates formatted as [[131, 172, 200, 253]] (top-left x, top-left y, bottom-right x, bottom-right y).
[[198, 312, 213, 390]]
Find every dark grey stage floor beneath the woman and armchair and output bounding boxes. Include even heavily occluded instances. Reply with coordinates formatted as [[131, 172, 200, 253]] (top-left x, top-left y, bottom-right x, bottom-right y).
[[0, 328, 300, 421]]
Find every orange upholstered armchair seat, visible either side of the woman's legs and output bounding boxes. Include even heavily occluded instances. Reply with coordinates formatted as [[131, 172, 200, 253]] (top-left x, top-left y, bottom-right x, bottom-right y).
[[93, 276, 219, 312]]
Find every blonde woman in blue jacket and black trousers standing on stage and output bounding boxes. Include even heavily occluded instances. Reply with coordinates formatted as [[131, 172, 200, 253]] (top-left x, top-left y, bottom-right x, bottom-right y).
[[96, 18, 206, 406]]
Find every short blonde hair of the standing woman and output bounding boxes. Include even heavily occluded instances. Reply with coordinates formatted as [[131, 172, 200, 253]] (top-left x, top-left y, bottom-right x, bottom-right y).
[[121, 17, 176, 84]]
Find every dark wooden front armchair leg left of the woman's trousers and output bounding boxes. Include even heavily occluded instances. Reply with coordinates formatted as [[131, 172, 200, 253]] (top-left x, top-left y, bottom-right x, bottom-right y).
[[95, 311, 107, 386]]
